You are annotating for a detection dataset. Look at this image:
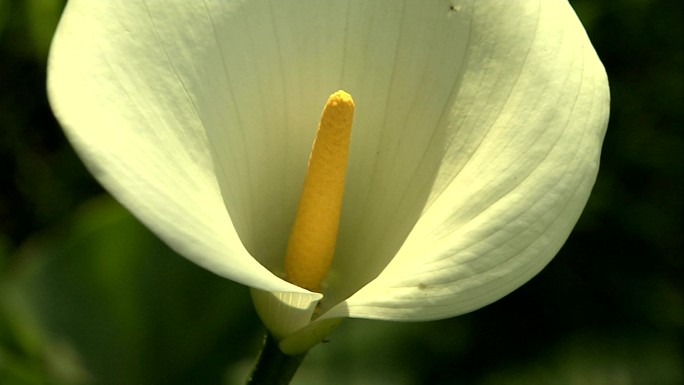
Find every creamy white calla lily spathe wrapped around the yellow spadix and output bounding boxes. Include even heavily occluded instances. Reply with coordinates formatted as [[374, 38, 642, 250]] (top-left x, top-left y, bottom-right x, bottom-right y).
[[48, 0, 609, 354]]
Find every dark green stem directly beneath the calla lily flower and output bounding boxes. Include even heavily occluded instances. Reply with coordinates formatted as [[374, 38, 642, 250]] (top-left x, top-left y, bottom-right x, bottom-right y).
[[247, 333, 306, 385]]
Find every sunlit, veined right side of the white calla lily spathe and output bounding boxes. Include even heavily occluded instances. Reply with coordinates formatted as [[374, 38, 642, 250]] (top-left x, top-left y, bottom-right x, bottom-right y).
[[323, 0, 609, 320]]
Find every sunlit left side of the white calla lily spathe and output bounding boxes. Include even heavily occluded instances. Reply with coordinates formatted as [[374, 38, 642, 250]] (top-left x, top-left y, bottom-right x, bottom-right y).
[[48, 0, 305, 292]]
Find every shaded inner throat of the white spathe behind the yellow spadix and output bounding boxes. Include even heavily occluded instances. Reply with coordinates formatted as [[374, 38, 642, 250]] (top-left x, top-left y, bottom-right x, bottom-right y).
[[192, 0, 468, 282]]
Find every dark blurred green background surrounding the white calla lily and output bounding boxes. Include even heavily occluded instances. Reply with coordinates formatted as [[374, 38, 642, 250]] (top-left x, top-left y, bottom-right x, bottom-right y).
[[0, 0, 684, 385]]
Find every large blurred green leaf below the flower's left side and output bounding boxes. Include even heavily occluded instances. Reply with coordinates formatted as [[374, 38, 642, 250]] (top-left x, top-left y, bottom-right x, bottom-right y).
[[0, 198, 260, 384]]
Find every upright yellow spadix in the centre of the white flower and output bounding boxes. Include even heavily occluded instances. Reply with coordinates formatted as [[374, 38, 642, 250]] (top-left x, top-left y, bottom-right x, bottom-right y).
[[285, 90, 354, 291]]
